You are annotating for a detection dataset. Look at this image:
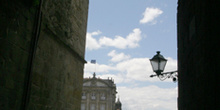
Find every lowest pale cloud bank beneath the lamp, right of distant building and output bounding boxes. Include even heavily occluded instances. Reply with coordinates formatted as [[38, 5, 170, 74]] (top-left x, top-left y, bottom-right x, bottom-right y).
[[117, 86, 177, 110]]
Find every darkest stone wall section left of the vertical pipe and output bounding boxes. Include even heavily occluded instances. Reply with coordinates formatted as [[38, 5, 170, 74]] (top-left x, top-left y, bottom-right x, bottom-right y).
[[0, 0, 36, 110]]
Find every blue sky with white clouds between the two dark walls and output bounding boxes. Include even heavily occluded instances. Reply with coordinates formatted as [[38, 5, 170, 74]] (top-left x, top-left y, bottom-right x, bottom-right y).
[[84, 0, 178, 110]]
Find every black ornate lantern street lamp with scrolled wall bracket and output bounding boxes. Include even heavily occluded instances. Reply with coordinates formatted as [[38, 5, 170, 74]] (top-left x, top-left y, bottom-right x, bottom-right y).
[[150, 51, 178, 82]]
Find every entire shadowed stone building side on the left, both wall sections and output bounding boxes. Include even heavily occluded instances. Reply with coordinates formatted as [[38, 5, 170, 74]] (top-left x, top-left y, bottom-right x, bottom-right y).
[[0, 0, 89, 110]]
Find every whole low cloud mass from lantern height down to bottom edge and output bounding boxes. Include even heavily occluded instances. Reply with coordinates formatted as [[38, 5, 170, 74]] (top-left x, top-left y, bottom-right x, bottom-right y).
[[84, 57, 177, 110]]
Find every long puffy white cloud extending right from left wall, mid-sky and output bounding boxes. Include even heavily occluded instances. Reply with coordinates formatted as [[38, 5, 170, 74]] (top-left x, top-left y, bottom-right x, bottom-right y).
[[86, 28, 141, 50]]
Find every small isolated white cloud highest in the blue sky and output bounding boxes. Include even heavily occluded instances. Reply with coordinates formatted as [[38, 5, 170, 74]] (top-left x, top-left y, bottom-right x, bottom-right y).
[[140, 7, 163, 24]]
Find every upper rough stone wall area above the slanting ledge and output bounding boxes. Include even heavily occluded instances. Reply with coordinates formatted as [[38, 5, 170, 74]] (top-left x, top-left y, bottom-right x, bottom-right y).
[[42, 0, 88, 58]]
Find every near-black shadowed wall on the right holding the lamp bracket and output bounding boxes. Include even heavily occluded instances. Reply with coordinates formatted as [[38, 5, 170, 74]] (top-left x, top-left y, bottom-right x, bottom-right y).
[[177, 0, 220, 110]]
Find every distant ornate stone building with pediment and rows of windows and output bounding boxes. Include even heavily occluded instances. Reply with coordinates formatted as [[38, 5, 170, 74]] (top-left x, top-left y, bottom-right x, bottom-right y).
[[81, 73, 117, 110]]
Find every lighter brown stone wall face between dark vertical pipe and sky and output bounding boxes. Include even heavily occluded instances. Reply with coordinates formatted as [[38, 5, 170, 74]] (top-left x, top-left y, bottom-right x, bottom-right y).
[[30, 0, 88, 110]]
